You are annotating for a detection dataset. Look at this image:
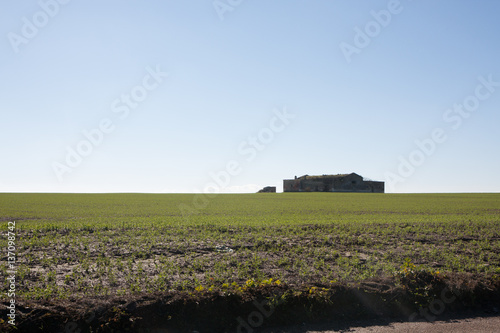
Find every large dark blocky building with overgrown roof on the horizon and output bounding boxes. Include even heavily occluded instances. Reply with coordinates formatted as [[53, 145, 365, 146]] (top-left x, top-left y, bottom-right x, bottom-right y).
[[283, 172, 384, 193]]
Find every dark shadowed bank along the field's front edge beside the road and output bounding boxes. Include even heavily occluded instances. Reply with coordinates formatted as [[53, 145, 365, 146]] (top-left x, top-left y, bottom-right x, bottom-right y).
[[0, 272, 500, 333]]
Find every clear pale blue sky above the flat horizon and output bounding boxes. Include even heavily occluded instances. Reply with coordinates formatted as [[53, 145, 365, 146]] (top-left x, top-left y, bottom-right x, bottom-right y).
[[0, 0, 500, 192]]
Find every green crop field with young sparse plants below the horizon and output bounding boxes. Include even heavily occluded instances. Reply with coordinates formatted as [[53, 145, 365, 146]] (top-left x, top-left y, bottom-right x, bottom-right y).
[[0, 193, 500, 331]]
